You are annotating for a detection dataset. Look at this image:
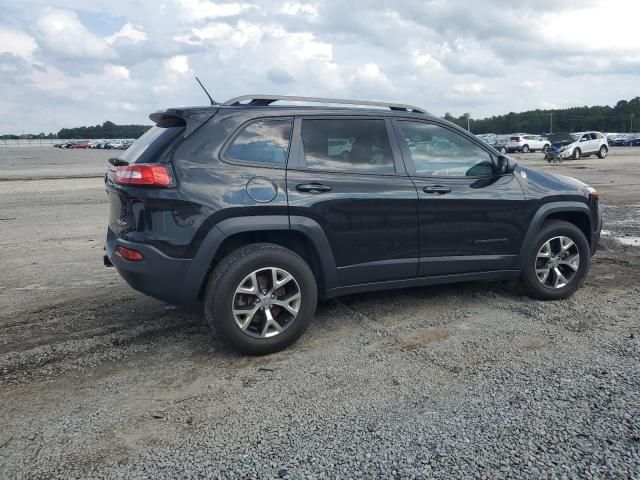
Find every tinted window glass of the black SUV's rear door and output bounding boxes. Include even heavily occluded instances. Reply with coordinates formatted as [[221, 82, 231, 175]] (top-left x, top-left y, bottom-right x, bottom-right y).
[[301, 119, 395, 174]]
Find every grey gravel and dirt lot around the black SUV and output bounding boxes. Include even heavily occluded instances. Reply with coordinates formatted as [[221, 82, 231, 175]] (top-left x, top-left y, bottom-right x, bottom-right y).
[[0, 147, 640, 479]]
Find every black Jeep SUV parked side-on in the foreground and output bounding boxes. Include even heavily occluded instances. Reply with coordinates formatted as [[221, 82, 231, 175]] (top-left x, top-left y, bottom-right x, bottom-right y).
[[105, 95, 601, 354]]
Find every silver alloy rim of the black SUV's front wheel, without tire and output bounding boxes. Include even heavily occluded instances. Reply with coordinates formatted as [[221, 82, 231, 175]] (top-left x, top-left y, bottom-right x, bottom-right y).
[[535, 236, 580, 288]]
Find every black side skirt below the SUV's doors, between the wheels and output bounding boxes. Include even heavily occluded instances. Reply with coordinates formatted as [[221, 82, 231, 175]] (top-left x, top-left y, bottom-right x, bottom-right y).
[[321, 270, 520, 298]]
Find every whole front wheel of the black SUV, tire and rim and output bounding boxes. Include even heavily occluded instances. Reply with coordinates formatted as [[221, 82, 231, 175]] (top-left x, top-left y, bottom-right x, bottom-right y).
[[522, 220, 591, 300]]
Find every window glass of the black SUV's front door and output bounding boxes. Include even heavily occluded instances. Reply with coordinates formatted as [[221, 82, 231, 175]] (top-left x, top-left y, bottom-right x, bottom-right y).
[[398, 121, 493, 177]]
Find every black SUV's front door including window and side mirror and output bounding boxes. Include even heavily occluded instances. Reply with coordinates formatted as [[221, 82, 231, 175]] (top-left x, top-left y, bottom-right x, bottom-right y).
[[395, 120, 527, 276]]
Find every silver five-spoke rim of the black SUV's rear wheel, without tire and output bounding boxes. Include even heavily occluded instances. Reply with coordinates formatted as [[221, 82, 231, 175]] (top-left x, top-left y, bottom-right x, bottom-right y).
[[231, 267, 302, 338]]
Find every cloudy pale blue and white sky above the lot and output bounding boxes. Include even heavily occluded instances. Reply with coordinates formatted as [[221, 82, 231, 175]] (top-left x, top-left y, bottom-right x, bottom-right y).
[[0, 0, 640, 133]]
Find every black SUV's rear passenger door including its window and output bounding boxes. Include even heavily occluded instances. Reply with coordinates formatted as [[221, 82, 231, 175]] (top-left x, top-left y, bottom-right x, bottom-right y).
[[287, 116, 419, 286]]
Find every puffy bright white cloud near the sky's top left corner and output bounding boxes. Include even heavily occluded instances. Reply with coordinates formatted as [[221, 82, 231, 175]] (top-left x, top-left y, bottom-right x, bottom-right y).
[[36, 9, 115, 60]]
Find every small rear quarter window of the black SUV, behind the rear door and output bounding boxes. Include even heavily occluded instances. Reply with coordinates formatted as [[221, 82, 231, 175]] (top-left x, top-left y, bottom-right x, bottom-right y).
[[226, 118, 291, 167]]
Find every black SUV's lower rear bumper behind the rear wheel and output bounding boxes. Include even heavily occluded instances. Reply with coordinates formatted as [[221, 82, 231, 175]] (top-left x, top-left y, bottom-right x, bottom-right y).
[[106, 229, 201, 304]]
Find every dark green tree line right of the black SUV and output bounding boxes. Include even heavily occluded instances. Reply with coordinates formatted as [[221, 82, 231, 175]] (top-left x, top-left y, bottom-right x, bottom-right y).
[[444, 97, 640, 134]]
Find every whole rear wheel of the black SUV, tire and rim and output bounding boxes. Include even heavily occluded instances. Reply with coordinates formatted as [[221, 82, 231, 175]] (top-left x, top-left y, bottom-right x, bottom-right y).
[[204, 243, 318, 355]]
